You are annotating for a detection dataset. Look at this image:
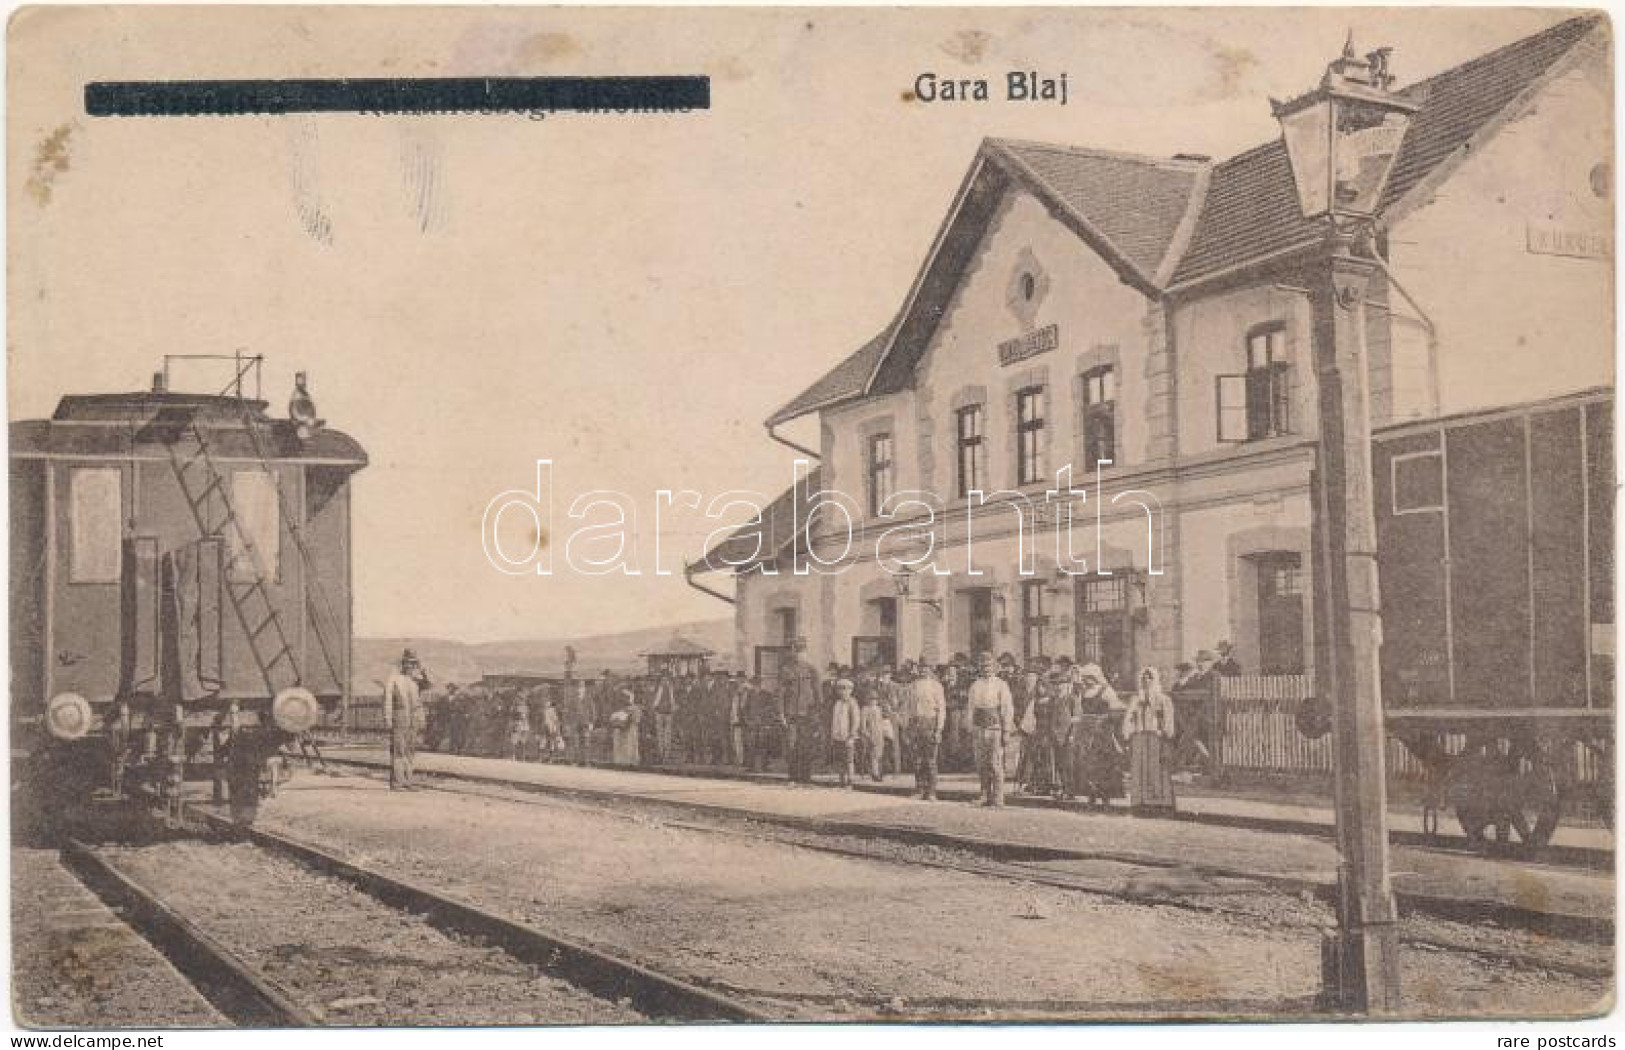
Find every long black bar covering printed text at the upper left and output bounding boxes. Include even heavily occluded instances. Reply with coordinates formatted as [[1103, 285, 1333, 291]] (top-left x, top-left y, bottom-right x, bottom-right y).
[[85, 76, 710, 117]]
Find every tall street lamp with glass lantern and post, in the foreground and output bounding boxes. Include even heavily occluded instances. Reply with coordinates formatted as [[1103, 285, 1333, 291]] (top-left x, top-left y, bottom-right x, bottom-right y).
[[1274, 36, 1419, 1013]]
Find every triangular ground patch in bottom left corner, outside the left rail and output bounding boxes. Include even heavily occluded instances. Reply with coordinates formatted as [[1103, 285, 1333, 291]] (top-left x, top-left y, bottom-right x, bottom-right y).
[[11, 848, 226, 1029]]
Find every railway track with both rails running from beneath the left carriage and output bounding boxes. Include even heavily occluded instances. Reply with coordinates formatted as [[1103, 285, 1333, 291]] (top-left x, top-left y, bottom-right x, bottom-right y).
[[62, 808, 767, 1027]]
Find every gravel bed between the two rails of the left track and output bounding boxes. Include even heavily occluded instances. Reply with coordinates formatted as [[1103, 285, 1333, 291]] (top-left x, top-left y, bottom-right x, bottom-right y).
[[98, 842, 644, 1026]]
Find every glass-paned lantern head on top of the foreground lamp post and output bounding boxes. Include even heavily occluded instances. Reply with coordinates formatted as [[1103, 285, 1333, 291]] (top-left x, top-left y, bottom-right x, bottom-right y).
[[1271, 34, 1419, 219]]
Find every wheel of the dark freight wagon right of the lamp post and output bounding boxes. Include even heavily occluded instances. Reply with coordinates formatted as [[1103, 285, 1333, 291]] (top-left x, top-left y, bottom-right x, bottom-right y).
[[1450, 754, 1563, 850]]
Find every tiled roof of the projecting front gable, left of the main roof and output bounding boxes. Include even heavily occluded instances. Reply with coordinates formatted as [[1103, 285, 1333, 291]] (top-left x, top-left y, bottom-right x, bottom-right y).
[[767, 138, 1206, 426]]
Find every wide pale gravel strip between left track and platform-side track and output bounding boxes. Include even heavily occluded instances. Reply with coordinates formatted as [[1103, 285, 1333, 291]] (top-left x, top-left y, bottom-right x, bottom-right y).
[[262, 777, 1610, 1019]]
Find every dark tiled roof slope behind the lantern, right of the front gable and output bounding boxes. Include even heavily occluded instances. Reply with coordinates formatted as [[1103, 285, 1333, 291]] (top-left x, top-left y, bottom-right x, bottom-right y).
[[1170, 15, 1602, 286]]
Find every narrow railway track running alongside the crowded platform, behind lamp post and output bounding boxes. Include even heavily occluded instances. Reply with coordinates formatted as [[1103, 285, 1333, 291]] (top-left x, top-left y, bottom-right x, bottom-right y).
[[316, 762, 1614, 978]]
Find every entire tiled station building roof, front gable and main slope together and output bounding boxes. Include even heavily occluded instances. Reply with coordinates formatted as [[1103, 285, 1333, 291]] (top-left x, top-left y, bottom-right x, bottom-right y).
[[767, 15, 1606, 426]]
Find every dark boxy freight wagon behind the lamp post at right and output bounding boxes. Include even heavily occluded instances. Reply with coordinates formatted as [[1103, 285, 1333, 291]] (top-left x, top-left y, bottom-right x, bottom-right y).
[[1372, 390, 1614, 847]]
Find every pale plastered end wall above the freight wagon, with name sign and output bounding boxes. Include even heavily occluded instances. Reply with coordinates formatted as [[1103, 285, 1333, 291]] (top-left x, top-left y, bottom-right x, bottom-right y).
[[1389, 47, 1614, 414]]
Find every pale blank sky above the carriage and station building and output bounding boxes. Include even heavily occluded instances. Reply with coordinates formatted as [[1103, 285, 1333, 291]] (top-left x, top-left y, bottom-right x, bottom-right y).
[[7, 8, 1563, 640]]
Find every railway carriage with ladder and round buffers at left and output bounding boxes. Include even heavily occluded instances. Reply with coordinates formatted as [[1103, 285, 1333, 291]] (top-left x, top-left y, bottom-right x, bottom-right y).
[[10, 358, 367, 821]]
